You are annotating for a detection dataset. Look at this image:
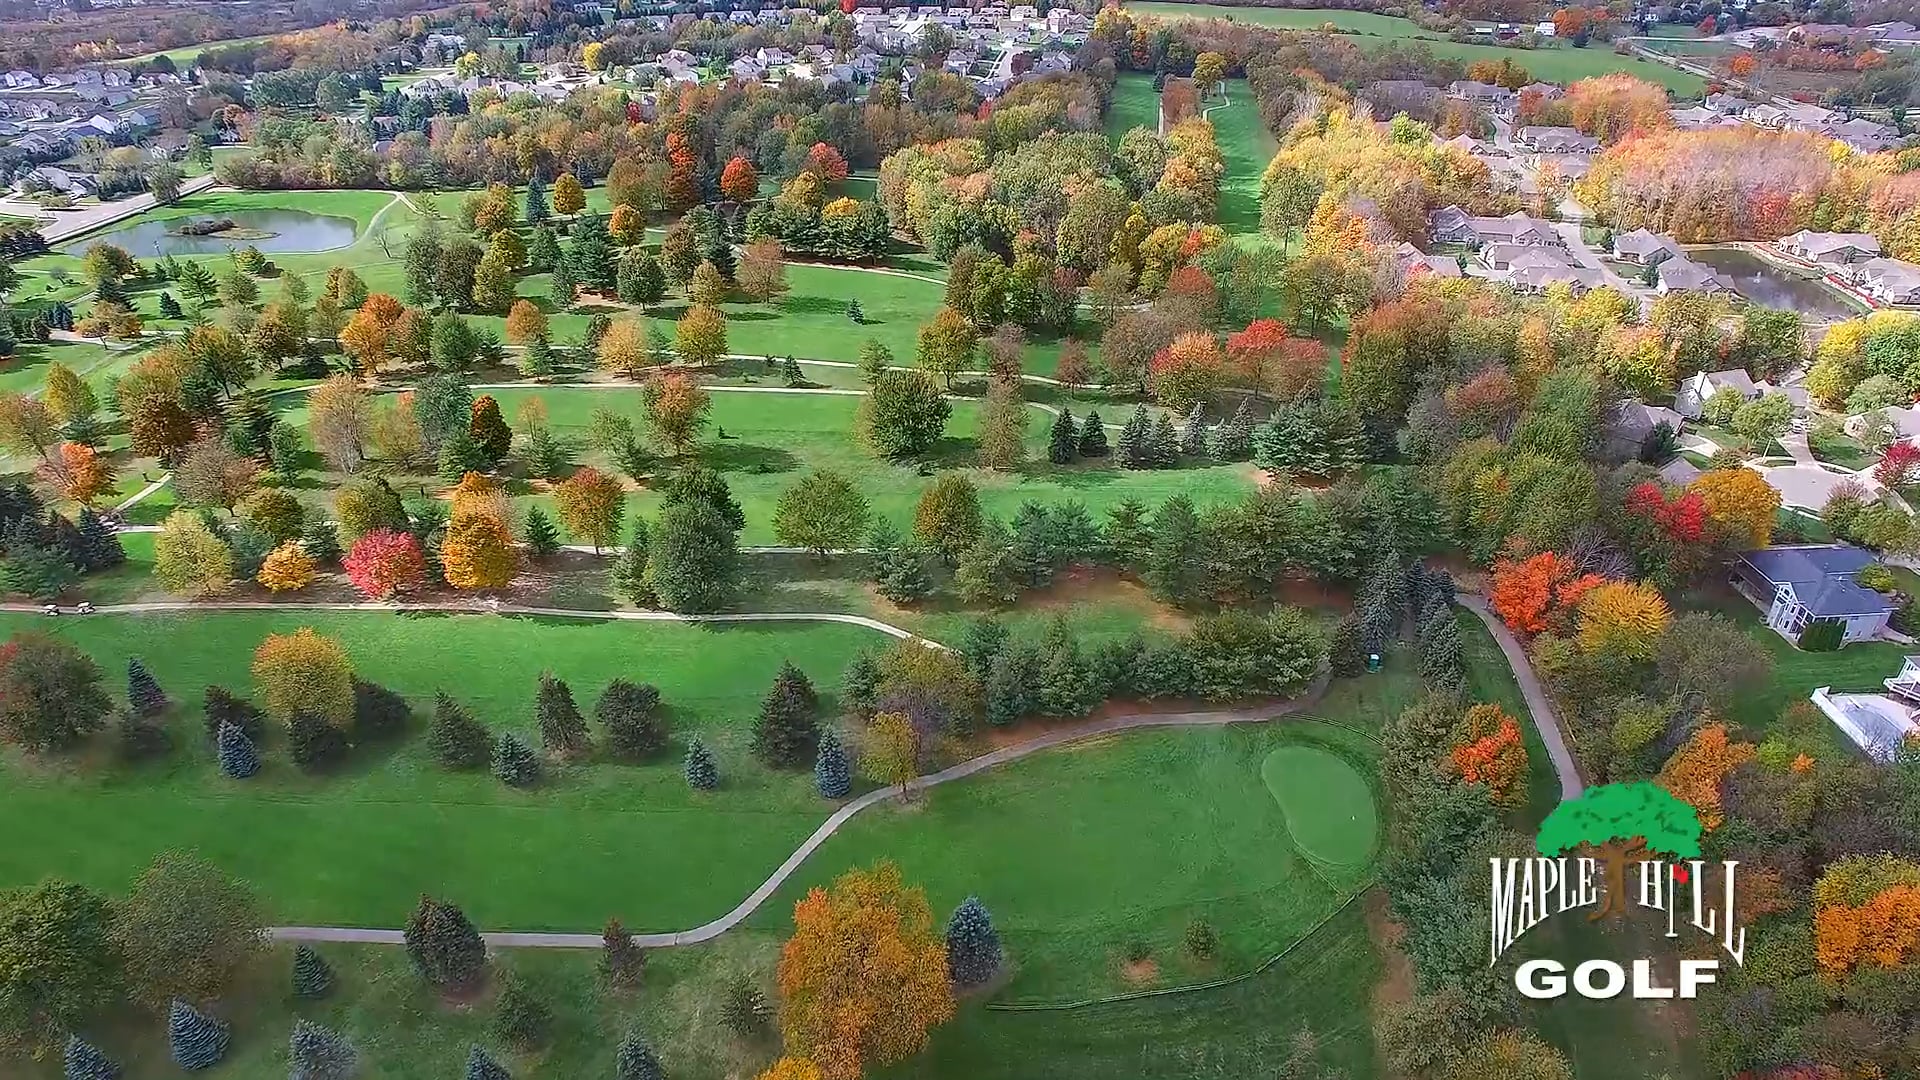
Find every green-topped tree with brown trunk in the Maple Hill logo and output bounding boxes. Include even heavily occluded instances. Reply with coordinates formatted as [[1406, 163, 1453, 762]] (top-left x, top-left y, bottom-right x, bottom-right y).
[[1534, 780, 1699, 922]]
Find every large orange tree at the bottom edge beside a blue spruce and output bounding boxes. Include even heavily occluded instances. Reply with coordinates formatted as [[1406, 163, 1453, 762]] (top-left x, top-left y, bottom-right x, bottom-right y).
[[780, 861, 954, 1080]]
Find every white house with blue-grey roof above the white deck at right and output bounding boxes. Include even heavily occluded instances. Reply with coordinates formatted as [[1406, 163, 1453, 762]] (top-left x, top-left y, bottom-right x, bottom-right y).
[[1734, 544, 1893, 642]]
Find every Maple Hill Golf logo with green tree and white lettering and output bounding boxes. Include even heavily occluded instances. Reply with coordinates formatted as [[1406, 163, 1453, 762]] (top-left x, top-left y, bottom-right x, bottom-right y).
[[1488, 780, 1747, 999]]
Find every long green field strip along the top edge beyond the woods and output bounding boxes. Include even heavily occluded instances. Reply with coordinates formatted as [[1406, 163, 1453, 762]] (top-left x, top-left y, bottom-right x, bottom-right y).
[[1127, 2, 1707, 98]]
